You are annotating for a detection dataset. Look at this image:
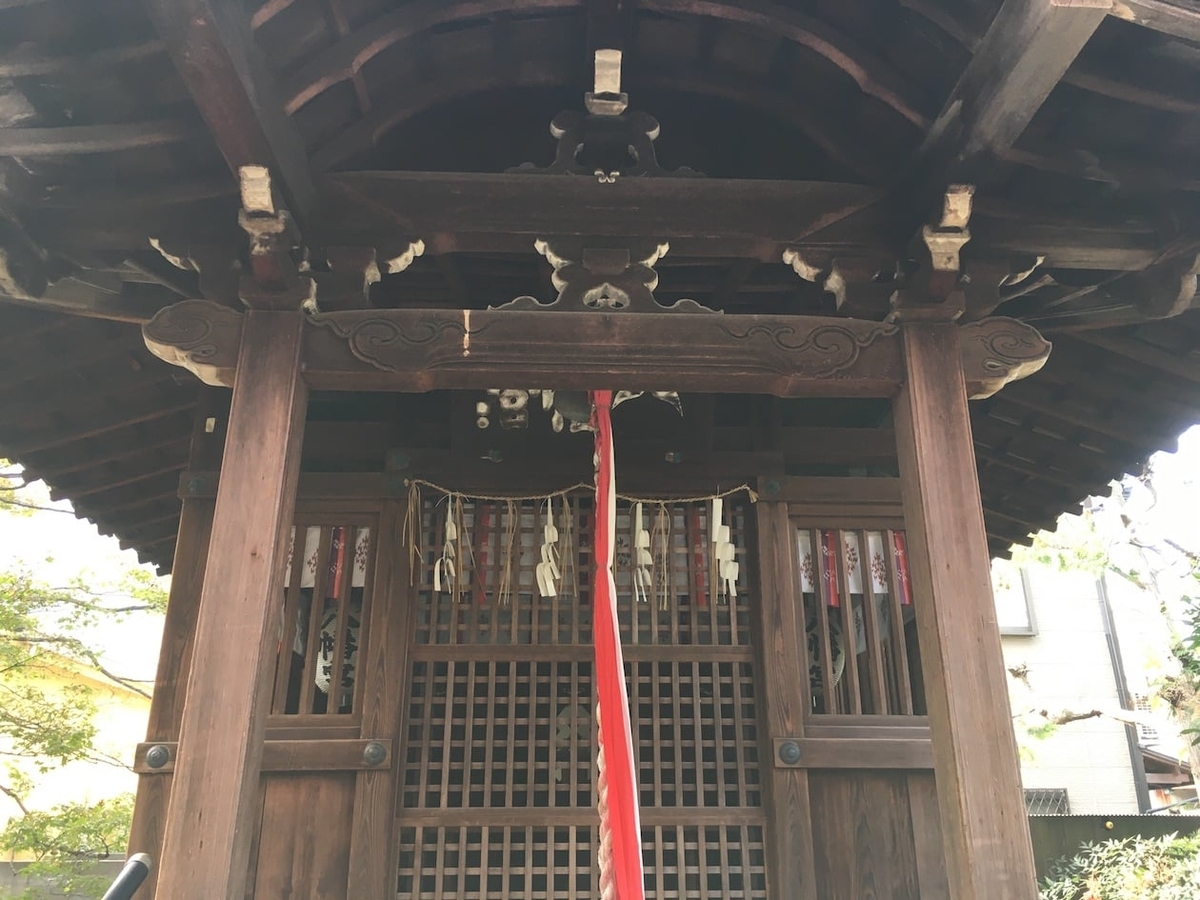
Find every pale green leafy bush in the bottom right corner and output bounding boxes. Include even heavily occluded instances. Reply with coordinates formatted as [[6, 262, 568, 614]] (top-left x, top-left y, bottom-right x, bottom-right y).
[[1040, 834, 1200, 900]]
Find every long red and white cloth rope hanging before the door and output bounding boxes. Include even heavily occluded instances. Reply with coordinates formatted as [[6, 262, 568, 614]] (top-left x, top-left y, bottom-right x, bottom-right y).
[[592, 391, 646, 900]]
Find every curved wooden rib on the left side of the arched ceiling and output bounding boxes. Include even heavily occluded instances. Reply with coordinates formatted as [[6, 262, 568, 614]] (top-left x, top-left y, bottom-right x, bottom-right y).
[[282, 0, 583, 114]]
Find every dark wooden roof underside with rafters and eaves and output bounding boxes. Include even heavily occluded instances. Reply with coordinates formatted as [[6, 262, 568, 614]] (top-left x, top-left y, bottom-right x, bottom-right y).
[[0, 0, 1200, 566]]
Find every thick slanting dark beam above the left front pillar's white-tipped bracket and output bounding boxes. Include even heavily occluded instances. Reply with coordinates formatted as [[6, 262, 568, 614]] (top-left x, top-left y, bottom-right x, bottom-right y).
[[143, 0, 316, 227]]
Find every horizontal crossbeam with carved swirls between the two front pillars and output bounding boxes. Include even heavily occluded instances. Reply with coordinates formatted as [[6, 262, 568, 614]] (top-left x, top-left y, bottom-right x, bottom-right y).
[[306, 310, 901, 396]]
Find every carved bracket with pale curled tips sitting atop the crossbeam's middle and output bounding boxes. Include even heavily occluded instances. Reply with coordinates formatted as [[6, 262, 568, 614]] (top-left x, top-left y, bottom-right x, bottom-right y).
[[492, 240, 715, 313]]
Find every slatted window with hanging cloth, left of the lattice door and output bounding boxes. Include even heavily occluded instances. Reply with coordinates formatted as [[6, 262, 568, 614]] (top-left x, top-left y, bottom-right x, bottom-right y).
[[271, 521, 374, 715]]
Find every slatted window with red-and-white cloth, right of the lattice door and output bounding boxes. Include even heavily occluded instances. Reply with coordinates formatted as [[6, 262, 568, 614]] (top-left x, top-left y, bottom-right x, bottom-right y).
[[796, 527, 924, 715]]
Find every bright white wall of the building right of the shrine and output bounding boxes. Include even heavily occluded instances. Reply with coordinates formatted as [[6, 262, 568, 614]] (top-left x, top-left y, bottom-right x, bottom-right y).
[[1002, 568, 1138, 815]]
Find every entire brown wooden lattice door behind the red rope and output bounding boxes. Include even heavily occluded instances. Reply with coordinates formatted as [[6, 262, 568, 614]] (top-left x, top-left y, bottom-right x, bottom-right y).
[[397, 498, 767, 900]]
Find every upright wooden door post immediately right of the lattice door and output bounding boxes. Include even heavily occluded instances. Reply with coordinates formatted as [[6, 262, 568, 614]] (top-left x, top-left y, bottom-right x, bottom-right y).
[[753, 500, 823, 900]]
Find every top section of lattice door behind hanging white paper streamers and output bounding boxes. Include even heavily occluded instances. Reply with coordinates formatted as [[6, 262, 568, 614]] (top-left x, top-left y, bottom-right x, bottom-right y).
[[415, 498, 750, 647]]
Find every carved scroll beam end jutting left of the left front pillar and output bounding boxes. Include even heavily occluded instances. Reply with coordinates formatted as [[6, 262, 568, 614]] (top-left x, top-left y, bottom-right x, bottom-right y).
[[142, 300, 244, 388]]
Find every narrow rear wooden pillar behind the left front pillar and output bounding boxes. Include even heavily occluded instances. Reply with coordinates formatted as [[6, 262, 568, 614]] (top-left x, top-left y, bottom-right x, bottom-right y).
[[128, 388, 228, 900]]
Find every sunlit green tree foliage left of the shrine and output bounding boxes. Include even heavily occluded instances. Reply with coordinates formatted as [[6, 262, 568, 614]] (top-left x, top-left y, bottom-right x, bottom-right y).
[[0, 462, 166, 899]]
